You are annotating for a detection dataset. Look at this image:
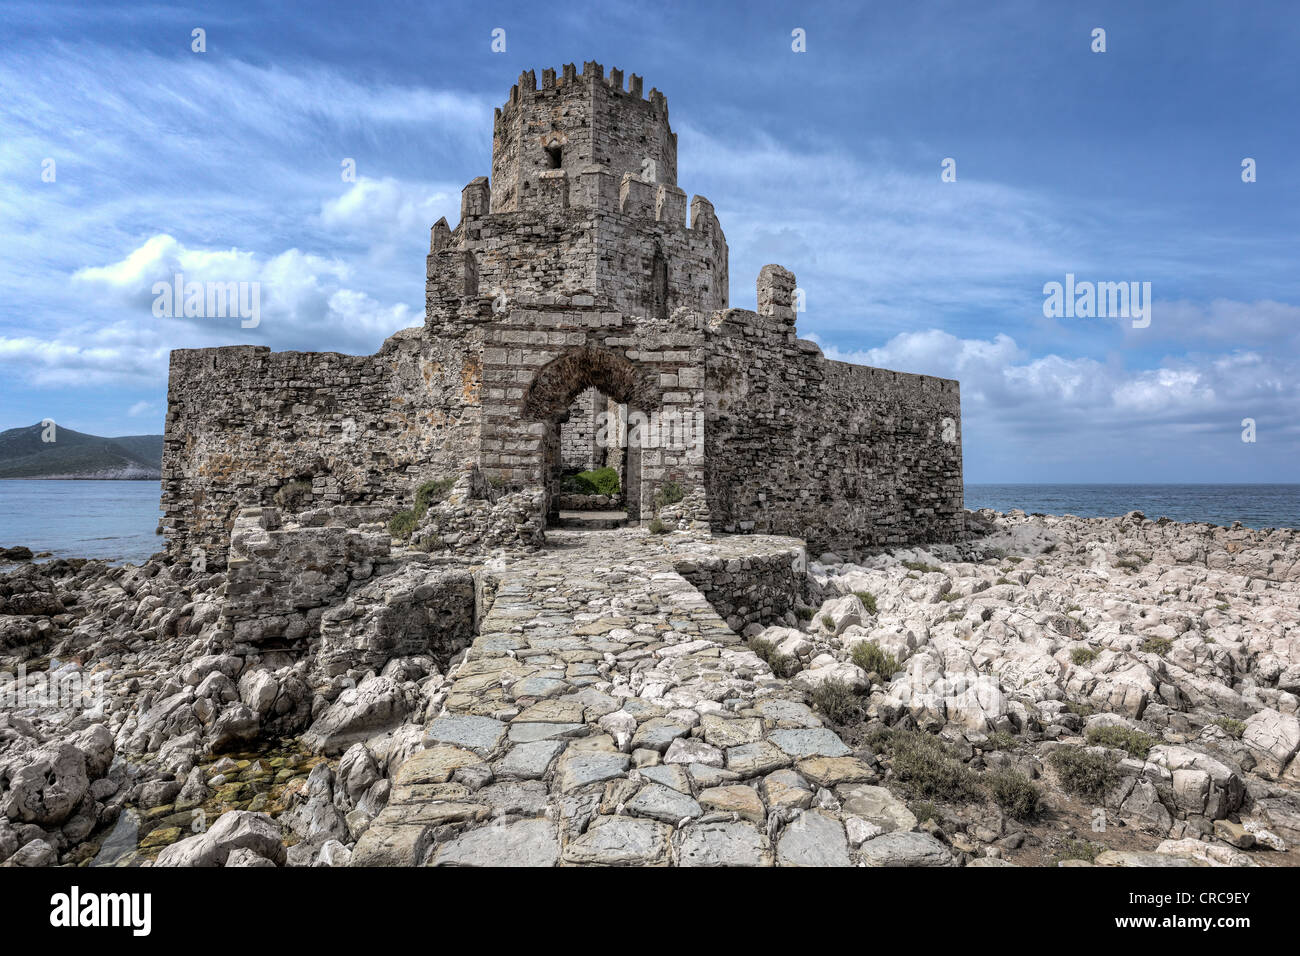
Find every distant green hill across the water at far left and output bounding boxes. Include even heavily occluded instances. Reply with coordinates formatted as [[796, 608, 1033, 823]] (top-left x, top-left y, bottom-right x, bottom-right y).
[[0, 424, 163, 480]]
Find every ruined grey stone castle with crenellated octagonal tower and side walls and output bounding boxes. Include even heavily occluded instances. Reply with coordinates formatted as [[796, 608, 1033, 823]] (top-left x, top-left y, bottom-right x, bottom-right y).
[[163, 62, 962, 564]]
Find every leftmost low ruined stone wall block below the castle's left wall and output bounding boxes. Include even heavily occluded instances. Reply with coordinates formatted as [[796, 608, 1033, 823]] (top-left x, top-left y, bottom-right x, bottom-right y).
[[221, 507, 391, 650]]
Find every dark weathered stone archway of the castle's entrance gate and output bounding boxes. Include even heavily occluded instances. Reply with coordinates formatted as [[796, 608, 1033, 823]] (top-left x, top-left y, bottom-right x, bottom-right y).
[[521, 346, 662, 523]]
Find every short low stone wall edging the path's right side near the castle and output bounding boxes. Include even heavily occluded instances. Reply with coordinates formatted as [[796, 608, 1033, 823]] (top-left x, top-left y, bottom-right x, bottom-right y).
[[673, 549, 807, 633]]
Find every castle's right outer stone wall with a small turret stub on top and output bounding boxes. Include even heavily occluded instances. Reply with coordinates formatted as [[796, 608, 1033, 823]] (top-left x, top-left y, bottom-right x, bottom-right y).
[[705, 267, 963, 554]]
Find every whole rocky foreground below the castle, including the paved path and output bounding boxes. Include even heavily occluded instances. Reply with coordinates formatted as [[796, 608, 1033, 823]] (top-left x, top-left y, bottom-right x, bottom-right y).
[[0, 511, 1300, 866]]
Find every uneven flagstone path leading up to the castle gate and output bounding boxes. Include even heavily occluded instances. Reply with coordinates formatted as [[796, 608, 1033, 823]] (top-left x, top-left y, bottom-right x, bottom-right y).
[[352, 531, 948, 866]]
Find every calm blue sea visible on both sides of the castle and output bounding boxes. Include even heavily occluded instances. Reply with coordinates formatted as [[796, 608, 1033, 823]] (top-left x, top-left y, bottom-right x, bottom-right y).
[[0, 481, 1300, 563]]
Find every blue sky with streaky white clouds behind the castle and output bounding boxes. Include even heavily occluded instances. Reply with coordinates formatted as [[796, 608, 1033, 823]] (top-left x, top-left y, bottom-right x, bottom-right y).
[[0, 0, 1300, 483]]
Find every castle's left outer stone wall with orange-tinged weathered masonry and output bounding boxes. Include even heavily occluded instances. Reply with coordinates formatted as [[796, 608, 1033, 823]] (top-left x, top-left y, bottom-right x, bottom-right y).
[[161, 328, 481, 567]]
